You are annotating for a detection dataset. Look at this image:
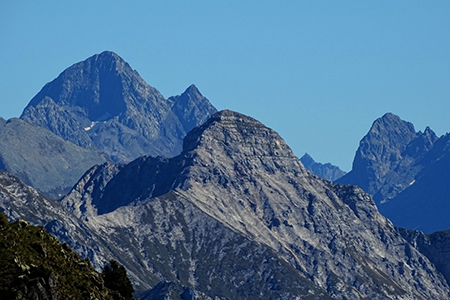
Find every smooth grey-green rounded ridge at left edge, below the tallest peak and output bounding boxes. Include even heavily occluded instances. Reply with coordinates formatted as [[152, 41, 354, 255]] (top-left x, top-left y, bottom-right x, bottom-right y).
[[0, 118, 108, 199]]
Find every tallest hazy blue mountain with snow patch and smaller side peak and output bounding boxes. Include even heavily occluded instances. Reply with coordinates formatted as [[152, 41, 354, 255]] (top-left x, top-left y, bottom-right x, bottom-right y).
[[20, 51, 216, 161]]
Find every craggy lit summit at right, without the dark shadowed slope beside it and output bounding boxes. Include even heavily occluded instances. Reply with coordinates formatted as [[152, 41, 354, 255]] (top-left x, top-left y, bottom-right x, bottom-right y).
[[337, 113, 438, 209]]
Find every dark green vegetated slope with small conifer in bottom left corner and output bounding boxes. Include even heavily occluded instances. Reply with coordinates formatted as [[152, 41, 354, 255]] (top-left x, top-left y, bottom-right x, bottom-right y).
[[0, 212, 134, 300]]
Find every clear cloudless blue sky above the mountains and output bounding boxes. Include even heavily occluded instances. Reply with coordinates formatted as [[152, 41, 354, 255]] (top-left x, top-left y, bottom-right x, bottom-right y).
[[0, 0, 450, 171]]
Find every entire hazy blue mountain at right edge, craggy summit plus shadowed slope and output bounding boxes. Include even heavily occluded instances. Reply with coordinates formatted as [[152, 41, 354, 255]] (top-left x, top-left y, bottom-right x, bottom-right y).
[[337, 114, 450, 233]]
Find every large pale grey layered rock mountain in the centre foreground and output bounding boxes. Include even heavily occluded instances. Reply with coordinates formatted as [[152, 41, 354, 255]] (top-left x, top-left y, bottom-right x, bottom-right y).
[[62, 111, 450, 299]]
